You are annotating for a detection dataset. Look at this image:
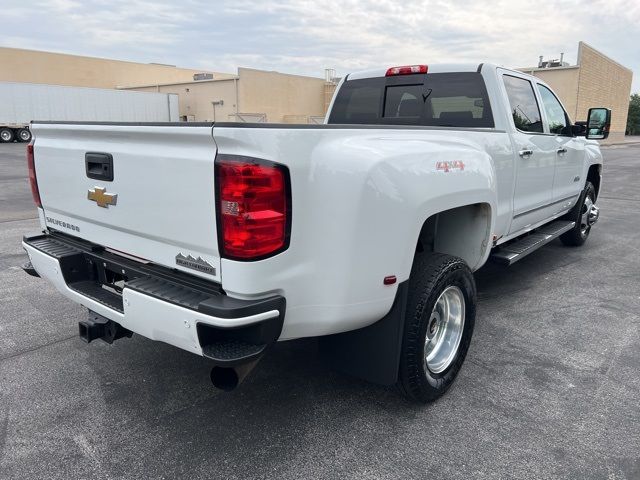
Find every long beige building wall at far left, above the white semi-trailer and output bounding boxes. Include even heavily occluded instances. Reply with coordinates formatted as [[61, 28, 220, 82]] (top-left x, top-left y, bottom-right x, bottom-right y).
[[0, 47, 234, 88]]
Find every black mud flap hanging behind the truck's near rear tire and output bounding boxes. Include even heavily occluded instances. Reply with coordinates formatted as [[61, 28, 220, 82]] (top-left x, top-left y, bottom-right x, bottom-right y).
[[319, 281, 409, 385]]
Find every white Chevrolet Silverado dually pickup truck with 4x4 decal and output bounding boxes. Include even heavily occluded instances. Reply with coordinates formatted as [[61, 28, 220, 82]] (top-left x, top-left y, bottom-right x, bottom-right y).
[[23, 63, 611, 402]]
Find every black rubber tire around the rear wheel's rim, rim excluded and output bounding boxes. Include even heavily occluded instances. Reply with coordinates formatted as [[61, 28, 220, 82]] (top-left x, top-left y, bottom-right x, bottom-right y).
[[397, 253, 476, 403]]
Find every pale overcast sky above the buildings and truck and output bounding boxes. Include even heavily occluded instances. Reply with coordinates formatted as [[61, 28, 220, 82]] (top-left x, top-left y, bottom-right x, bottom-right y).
[[5, 0, 640, 92]]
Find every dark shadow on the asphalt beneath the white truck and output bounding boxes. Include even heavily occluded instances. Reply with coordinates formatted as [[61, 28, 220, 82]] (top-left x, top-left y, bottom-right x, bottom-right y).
[[67, 240, 580, 464]]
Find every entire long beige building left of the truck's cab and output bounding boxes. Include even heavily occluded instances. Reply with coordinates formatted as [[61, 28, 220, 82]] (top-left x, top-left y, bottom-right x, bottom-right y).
[[0, 47, 335, 123]]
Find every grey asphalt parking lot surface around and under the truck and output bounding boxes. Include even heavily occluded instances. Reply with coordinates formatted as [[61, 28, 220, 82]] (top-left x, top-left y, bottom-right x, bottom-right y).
[[0, 144, 640, 479]]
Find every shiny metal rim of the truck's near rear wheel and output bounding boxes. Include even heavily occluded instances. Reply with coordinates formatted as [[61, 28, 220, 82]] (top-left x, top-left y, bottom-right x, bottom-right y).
[[424, 286, 465, 374]]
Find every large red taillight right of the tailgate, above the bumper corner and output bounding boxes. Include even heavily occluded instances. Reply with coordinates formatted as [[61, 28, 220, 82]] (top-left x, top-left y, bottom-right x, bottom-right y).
[[216, 155, 291, 260]]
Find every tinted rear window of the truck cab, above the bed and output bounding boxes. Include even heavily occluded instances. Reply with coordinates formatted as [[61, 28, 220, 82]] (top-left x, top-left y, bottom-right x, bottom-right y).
[[329, 72, 494, 128]]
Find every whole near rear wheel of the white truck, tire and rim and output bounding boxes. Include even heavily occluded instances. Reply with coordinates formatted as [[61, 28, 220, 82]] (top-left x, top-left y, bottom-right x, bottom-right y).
[[398, 253, 476, 403]]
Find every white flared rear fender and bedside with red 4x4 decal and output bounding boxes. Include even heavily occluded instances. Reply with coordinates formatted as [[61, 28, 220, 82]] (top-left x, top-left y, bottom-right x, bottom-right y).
[[214, 126, 498, 339]]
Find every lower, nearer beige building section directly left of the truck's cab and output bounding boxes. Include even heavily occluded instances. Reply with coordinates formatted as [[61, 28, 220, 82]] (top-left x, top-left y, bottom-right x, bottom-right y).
[[126, 68, 335, 123]]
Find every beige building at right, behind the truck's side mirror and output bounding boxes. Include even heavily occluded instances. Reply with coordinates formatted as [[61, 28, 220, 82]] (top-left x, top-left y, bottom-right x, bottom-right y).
[[519, 42, 633, 142]]
